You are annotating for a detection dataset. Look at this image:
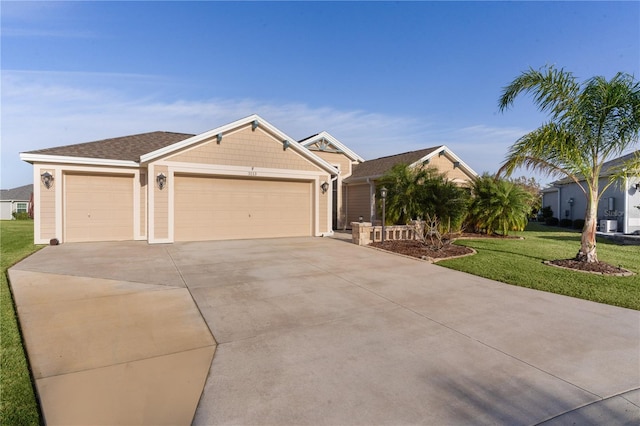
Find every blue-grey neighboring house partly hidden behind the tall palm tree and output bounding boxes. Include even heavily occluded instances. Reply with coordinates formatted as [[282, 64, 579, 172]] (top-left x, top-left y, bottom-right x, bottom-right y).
[[542, 151, 640, 234]]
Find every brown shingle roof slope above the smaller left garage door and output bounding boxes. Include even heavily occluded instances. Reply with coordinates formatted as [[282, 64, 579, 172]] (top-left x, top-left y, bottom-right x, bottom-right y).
[[27, 132, 194, 162]]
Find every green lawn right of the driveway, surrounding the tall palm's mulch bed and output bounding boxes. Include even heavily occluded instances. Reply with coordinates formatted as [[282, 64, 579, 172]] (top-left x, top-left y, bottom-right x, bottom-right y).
[[438, 223, 640, 310]]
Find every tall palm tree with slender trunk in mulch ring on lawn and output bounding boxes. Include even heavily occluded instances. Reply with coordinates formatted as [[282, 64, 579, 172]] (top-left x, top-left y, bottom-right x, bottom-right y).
[[498, 66, 640, 262]]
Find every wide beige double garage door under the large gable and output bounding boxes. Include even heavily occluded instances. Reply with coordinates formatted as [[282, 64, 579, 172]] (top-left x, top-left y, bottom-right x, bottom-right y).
[[174, 176, 313, 241]]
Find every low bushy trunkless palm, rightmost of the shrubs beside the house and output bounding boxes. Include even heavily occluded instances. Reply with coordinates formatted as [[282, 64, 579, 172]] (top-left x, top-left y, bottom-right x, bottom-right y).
[[467, 174, 534, 236]]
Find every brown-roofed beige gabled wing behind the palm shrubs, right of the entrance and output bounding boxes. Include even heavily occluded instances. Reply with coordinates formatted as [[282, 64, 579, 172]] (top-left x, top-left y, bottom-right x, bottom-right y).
[[344, 145, 478, 224]]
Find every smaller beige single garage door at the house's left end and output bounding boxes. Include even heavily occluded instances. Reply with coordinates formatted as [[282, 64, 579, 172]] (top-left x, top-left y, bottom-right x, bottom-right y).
[[64, 174, 133, 242]]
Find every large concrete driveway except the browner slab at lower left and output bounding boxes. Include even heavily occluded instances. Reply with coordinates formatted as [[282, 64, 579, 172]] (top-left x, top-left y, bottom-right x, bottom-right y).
[[10, 238, 640, 425]]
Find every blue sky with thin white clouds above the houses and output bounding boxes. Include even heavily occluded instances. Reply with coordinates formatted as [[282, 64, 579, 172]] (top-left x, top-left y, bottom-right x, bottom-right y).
[[0, 1, 640, 188]]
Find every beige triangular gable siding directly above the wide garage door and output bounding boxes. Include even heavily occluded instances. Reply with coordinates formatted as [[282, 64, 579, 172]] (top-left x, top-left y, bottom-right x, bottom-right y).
[[167, 125, 319, 171]]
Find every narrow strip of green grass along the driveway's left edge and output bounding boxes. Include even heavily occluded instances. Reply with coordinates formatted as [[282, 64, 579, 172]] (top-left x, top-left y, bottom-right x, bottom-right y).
[[0, 220, 41, 425]]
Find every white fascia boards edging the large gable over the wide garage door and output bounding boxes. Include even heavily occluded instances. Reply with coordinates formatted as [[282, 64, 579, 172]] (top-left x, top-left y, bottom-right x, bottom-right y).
[[140, 114, 339, 175]]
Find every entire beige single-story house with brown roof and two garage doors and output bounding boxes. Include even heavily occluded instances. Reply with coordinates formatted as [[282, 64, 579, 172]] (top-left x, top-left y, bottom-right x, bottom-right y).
[[20, 115, 475, 244]]
